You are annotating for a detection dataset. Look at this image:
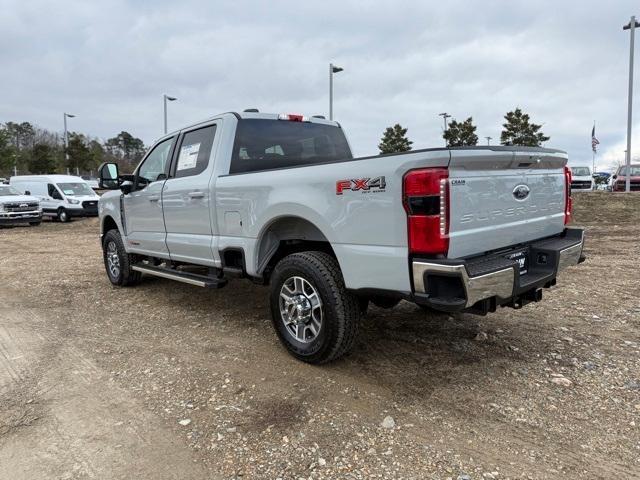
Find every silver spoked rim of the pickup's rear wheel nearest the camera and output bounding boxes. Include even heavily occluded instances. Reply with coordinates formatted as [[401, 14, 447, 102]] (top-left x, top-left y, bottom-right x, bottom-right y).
[[280, 277, 322, 343]]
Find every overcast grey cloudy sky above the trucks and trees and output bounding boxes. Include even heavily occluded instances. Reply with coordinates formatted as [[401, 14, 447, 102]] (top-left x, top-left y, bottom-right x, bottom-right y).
[[0, 0, 640, 171]]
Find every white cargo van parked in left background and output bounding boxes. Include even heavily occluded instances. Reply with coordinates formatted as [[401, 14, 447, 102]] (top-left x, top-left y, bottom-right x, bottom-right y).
[[9, 175, 100, 222]]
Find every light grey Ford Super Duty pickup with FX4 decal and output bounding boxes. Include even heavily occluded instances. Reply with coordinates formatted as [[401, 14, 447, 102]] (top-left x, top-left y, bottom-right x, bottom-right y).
[[99, 111, 584, 363]]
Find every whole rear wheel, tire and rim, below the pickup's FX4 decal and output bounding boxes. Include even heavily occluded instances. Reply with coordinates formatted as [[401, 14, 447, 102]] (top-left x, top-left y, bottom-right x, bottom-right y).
[[270, 252, 360, 364]]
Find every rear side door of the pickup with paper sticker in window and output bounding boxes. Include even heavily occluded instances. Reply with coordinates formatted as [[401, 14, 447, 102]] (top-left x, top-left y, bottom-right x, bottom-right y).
[[162, 122, 218, 266]]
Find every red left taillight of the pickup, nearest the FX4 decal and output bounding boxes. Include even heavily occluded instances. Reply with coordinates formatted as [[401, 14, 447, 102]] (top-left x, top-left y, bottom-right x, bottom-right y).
[[403, 168, 449, 255]]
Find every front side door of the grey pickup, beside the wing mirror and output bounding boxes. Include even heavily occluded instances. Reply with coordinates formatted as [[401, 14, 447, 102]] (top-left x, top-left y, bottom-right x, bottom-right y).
[[123, 137, 175, 257]]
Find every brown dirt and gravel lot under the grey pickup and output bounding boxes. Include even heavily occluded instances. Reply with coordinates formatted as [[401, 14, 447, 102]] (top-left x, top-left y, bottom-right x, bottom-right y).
[[0, 193, 640, 479]]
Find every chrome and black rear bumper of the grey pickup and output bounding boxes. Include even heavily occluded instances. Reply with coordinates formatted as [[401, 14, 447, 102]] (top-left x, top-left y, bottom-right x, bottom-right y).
[[412, 228, 584, 313]]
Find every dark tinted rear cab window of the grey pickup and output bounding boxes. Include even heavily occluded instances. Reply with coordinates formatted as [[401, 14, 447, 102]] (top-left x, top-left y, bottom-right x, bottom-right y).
[[229, 119, 353, 173]]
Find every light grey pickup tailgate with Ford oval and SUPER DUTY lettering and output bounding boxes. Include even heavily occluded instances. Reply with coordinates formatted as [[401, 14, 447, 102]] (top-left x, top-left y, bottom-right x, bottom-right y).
[[448, 148, 567, 258]]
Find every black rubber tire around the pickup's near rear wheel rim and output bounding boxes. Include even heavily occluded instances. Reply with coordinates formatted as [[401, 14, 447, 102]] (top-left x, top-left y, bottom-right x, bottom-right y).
[[270, 252, 360, 364]]
